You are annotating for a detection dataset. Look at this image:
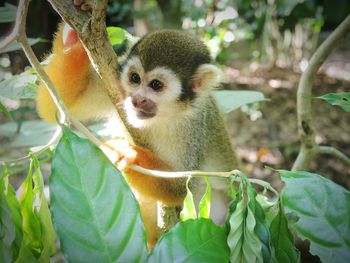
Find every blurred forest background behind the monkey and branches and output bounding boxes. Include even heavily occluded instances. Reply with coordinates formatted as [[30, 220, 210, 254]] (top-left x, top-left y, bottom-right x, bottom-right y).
[[0, 0, 350, 262]]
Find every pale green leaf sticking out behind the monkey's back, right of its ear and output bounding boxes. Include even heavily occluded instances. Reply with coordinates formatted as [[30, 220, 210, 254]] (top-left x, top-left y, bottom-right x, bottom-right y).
[[214, 90, 266, 113]]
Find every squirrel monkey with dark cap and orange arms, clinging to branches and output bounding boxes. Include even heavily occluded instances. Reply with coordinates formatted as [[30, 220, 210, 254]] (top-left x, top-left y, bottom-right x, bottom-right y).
[[37, 1, 239, 248]]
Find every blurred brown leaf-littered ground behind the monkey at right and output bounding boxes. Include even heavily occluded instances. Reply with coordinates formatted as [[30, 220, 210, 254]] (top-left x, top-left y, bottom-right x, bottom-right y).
[[226, 59, 350, 191]]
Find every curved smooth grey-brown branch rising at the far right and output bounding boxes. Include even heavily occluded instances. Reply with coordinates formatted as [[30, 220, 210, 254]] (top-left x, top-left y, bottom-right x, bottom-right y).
[[292, 15, 350, 171]]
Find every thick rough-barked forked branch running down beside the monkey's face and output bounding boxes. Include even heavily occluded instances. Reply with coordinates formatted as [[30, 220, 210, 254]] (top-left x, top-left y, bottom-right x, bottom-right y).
[[48, 0, 137, 144]]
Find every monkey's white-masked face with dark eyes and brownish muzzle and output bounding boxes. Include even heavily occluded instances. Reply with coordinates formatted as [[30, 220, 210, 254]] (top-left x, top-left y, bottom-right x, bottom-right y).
[[121, 56, 183, 128]]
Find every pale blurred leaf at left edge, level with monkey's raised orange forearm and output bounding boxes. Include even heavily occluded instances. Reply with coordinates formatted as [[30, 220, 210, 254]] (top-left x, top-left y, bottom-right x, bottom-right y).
[[0, 72, 38, 100]]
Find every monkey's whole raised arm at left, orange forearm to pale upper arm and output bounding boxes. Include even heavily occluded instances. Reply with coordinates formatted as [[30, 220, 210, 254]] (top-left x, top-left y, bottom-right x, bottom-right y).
[[37, 23, 113, 122]]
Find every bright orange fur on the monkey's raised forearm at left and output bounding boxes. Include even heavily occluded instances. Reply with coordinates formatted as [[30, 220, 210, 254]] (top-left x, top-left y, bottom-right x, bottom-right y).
[[37, 23, 91, 122]]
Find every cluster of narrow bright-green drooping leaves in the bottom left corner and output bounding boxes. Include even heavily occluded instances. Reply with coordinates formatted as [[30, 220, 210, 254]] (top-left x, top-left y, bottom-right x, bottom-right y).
[[0, 157, 56, 263]]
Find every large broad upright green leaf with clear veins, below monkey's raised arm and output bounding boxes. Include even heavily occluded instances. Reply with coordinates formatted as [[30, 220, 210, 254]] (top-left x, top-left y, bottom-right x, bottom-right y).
[[50, 128, 147, 262]]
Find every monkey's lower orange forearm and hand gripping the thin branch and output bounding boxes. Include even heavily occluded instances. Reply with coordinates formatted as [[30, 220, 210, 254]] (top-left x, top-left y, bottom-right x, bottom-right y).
[[102, 140, 186, 206]]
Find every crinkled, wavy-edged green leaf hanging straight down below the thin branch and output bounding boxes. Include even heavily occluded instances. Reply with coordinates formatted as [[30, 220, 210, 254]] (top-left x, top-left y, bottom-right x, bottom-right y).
[[227, 175, 264, 262]]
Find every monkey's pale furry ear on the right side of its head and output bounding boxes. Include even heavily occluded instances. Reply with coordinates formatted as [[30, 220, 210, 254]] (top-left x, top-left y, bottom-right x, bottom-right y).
[[192, 64, 222, 92]]
